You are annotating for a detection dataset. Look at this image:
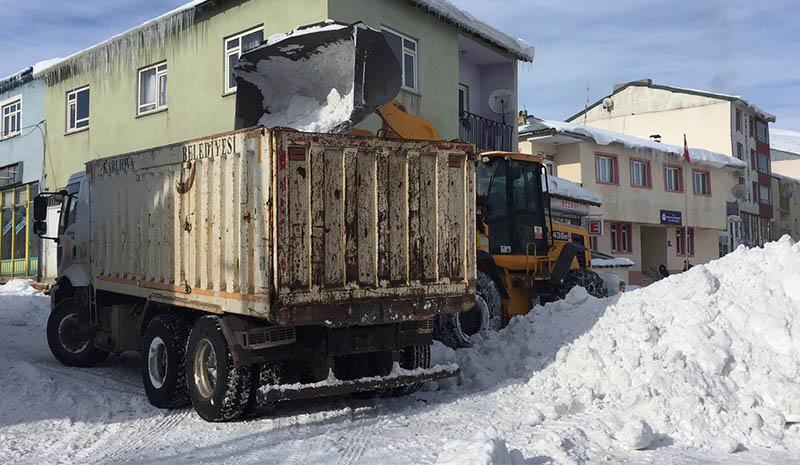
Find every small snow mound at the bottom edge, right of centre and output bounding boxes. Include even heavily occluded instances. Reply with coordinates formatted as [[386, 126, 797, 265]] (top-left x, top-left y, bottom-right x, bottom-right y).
[[436, 431, 525, 465]]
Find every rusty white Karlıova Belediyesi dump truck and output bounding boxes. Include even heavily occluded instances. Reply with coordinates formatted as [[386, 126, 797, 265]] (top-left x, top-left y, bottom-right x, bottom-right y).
[[34, 127, 477, 421]]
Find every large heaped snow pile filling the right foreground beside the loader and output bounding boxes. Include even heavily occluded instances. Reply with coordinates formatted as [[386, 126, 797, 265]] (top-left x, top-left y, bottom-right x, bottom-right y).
[[446, 236, 800, 453]]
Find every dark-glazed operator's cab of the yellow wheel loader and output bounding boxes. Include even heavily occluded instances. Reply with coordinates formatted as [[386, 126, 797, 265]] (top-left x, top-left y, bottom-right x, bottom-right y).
[[477, 152, 549, 255]]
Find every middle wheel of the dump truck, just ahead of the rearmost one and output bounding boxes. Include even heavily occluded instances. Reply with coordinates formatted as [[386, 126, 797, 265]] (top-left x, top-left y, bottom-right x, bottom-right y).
[[141, 314, 191, 408]]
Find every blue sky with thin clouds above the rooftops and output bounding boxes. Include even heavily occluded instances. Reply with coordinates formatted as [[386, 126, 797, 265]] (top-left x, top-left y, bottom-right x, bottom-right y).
[[0, 0, 800, 130]]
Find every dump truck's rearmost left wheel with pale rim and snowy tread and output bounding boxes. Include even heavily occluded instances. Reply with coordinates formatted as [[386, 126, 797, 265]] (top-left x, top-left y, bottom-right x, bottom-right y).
[[186, 316, 251, 421]]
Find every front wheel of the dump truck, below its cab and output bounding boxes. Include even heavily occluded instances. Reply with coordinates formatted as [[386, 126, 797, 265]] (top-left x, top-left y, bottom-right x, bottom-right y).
[[47, 297, 109, 367]]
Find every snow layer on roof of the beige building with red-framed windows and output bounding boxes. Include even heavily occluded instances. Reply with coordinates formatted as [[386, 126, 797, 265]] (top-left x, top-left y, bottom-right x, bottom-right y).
[[519, 119, 747, 169]]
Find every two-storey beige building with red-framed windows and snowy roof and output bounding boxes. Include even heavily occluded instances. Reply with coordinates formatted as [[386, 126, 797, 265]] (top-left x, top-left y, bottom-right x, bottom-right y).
[[519, 118, 747, 285]]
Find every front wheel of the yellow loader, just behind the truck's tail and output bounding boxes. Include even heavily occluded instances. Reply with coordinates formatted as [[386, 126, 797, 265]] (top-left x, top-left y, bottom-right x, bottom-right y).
[[433, 271, 503, 349]]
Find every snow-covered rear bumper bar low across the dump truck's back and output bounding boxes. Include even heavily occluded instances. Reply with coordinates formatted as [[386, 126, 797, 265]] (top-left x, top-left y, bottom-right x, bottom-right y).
[[256, 363, 461, 403]]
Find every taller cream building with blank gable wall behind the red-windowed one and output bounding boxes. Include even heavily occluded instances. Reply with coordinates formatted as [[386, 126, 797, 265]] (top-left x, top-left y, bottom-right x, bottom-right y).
[[567, 79, 776, 249]]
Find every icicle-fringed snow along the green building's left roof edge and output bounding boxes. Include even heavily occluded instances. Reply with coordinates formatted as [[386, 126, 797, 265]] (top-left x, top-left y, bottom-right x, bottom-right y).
[[34, 0, 210, 80]]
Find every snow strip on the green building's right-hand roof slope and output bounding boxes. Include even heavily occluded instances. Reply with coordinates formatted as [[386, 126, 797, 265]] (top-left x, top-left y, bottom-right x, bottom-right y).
[[408, 0, 534, 61]]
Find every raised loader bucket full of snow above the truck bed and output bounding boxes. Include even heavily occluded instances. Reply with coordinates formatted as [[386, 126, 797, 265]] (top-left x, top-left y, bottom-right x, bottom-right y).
[[233, 23, 401, 133]]
